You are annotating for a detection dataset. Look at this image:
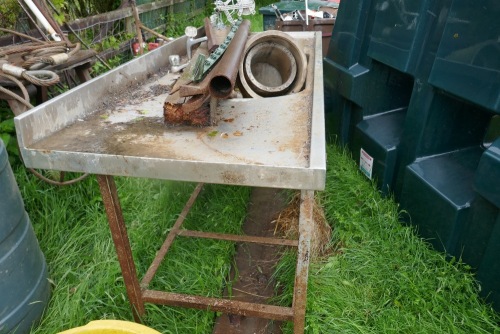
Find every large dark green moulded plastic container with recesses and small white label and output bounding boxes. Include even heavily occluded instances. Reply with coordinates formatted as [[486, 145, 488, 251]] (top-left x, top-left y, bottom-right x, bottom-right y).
[[324, 0, 500, 309]]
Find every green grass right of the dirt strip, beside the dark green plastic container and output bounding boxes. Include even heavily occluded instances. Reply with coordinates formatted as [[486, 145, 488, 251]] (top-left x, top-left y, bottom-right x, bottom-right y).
[[276, 146, 500, 333]]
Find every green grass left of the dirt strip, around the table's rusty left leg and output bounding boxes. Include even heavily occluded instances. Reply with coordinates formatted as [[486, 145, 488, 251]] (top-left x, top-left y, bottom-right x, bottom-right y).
[[16, 168, 249, 333]]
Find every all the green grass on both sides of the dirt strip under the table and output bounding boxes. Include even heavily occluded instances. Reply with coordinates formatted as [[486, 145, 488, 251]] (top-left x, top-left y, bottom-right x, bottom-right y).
[[16, 142, 500, 334]]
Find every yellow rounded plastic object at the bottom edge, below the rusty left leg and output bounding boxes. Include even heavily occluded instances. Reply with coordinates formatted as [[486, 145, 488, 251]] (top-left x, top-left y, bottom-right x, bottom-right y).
[[58, 320, 160, 334]]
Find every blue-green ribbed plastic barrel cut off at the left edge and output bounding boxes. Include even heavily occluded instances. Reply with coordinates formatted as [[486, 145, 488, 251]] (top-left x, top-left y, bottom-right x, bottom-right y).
[[0, 140, 50, 334]]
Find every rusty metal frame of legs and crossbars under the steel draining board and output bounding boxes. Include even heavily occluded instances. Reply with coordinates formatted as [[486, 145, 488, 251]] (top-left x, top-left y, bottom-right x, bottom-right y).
[[97, 175, 314, 334]]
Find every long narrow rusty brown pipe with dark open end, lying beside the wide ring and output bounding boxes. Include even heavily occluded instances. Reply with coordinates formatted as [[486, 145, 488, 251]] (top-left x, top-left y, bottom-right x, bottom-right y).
[[208, 20, 250, 99]]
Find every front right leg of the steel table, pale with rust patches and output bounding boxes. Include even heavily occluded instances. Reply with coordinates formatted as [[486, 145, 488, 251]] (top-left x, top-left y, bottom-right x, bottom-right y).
[[292, 190, 314, 334]]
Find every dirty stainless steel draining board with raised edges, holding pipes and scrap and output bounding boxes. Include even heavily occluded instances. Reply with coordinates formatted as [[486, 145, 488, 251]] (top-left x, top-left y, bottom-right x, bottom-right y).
[[15, 32, 326, 190]]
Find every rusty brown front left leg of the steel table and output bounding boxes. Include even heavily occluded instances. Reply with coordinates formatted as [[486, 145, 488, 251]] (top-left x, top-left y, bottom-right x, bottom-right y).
[[97, 175, 145, 322]]
